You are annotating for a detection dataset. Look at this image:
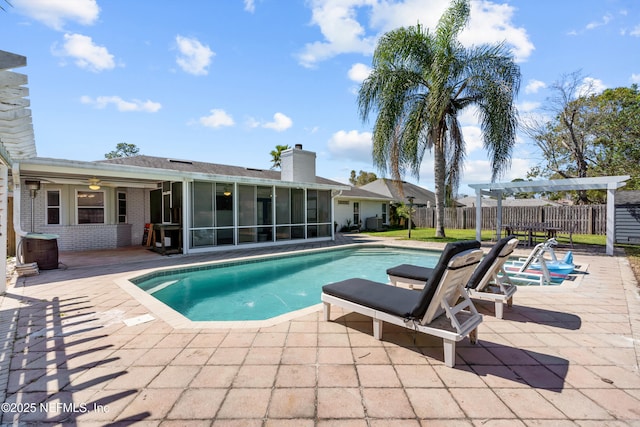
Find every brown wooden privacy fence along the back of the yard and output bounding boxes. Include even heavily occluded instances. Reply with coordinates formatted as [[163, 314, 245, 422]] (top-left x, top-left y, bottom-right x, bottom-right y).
[[413, 205, 607, 235]]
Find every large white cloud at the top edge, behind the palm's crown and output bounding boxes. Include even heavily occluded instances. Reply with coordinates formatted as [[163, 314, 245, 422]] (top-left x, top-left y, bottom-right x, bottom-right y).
[[298, 0, 534, 67]]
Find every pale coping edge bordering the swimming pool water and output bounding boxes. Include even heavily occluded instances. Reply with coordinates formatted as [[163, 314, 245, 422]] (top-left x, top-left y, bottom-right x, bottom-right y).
[[114, 242, 588, 329]]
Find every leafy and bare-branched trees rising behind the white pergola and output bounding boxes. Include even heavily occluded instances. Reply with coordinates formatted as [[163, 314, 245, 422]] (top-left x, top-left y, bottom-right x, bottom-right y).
[[524, 72, 640, 204]]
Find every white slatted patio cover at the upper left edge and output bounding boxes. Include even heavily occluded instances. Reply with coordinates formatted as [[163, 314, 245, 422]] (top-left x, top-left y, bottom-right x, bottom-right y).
[[0, 50, 36, 165]]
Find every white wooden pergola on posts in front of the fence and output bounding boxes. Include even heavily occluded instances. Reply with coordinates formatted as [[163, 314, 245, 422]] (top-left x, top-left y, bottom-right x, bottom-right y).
[[469, 175, 631, 255]]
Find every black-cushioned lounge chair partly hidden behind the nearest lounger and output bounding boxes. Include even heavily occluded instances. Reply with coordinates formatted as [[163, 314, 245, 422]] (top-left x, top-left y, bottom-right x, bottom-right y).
[[387, 236, 518, 319]]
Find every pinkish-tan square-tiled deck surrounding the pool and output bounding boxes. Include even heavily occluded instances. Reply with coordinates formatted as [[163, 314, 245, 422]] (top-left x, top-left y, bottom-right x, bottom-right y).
[[0, 235, 640, 427]]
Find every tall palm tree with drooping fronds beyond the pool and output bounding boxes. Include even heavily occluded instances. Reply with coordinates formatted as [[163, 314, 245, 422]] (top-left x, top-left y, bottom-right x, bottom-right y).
[[358, 0, 520, 237]]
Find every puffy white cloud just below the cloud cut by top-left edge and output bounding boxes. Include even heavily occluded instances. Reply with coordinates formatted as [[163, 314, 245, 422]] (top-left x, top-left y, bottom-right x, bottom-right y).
[[53, 34, 116, 72]]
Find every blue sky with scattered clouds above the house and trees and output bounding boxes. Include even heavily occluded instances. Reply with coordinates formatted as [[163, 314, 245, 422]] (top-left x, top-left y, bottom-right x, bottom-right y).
[[0, 0, 640, 194]]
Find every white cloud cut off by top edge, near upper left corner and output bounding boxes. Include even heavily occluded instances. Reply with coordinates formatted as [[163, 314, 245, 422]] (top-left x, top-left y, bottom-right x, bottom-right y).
[[11, 0, 100, 30]]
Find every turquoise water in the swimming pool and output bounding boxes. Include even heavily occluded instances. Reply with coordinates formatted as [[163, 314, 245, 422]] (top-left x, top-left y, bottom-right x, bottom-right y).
[[132, 247, 440, 321]]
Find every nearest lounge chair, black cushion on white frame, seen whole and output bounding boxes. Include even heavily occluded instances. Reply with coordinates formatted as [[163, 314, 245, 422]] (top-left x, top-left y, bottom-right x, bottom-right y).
[[321, 240, 482, 367]]
